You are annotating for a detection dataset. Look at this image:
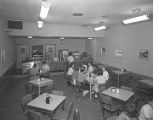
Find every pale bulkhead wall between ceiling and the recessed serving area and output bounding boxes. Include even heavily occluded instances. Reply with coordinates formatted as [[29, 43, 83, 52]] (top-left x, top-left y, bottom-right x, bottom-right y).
[[8, 23, 104, 37]]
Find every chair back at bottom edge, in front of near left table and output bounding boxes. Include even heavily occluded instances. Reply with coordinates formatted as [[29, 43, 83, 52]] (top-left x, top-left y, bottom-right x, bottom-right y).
[[27, 110, 41, 120]]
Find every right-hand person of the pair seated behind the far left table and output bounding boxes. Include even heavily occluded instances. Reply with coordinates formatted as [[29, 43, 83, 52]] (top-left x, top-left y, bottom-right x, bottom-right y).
[[40, 61, 50, 77]]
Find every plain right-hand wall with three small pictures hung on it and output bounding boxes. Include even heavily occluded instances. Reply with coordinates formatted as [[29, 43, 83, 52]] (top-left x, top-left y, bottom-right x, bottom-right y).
[[93, 22, 153, 77]]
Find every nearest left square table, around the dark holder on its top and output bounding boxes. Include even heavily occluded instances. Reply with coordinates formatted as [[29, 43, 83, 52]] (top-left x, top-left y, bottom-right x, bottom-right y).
[[27, 93, 66, 120]]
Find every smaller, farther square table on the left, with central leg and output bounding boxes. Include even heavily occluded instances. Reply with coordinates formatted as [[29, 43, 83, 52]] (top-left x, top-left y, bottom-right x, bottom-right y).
[[28, 78, 54, 95]]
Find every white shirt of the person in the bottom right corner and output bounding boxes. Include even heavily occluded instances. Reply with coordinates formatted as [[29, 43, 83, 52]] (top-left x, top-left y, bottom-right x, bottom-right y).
[[139, 104, 153, 120]]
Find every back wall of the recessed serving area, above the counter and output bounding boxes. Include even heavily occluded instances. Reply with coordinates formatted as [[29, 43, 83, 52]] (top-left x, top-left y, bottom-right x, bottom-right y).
[[15, 38, 86, 56]]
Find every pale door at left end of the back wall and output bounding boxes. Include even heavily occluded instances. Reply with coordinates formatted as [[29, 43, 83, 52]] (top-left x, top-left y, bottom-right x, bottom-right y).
[[16, 44, 29, 69]]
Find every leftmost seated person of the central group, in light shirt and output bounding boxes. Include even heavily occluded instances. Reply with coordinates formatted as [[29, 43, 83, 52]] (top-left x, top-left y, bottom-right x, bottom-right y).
[[67, 63, 74, 86]]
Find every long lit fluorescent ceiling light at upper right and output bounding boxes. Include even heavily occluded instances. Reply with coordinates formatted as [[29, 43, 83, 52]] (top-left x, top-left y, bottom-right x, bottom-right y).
[[122, 15, 149, 24]]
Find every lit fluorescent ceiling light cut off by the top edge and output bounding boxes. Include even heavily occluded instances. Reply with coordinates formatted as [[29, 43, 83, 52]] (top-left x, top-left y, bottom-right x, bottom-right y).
[[39, 0, 51, 19]]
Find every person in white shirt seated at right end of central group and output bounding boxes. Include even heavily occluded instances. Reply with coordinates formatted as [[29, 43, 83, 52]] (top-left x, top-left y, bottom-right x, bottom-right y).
[[93, 67, 109, 97]]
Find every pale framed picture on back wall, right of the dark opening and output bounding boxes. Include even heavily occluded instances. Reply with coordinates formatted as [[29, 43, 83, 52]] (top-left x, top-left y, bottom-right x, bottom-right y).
[[45, 44, 56, 60]]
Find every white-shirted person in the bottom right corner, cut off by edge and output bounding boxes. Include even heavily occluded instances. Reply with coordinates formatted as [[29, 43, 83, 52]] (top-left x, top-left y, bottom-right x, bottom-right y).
[[139, 96, 153, 120]]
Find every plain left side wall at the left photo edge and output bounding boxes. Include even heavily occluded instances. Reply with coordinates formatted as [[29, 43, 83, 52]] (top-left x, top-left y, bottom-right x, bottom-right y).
[[0, 17, 16, 77]]
